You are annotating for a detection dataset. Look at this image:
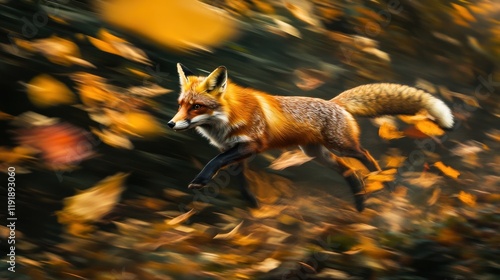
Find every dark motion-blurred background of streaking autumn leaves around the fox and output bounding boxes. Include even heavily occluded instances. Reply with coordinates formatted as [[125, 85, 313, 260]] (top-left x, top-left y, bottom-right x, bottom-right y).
[[0, 0, 500, 280]]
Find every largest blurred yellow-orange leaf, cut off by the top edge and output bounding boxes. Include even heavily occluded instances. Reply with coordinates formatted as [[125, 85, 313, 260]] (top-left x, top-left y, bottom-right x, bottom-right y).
[[97, 0, 237, 50]]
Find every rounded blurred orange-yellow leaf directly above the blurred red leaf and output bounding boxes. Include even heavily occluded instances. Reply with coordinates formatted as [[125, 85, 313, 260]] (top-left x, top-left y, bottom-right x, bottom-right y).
[[26, 74, 76, 108]]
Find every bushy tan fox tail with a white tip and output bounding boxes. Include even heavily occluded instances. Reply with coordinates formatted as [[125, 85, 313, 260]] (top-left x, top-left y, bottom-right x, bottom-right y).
[[331, 83, 453, 129]]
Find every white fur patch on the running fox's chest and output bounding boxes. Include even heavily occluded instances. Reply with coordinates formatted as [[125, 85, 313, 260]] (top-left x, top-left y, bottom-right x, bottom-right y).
[[196, 116, 250, 151]]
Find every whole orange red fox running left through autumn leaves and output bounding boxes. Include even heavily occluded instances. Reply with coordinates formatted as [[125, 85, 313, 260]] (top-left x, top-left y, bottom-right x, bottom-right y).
[[168, 63, 453, 211]]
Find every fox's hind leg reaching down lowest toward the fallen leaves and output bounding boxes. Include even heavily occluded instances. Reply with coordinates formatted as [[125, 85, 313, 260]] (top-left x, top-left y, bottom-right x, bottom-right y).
[[300, 144, 365, 212]]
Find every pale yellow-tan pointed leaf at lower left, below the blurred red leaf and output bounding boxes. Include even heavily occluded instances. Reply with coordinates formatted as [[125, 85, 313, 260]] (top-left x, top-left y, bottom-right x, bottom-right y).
[[57, 173, 128, 223]]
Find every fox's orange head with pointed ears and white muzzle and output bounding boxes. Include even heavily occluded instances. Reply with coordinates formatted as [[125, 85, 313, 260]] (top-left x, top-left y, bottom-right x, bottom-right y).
[[168, 63, 227, 130]]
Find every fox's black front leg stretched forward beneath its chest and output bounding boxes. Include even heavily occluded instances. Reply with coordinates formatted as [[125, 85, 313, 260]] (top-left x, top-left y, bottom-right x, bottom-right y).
[[188, 143, 255, 189]]
